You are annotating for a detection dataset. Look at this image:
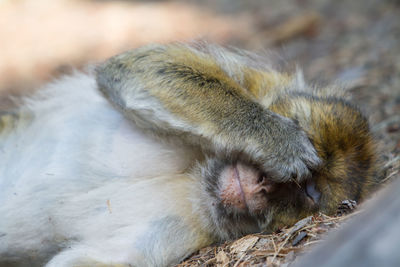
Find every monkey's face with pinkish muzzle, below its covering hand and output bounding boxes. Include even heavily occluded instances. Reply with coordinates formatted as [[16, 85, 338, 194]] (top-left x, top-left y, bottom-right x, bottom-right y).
[[202, 159, 321, 238]]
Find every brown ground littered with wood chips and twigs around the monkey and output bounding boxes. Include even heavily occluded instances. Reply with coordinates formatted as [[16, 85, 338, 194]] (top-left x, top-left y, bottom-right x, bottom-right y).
[[0, 0, 400, 267]]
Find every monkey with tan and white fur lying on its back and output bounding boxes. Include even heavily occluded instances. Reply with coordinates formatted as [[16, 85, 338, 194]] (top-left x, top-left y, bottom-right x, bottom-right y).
[[0, 43, 378, 267]]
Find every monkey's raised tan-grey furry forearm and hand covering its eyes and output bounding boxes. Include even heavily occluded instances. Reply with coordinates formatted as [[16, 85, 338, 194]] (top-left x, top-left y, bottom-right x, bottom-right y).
[[97, 46, 319, 182]]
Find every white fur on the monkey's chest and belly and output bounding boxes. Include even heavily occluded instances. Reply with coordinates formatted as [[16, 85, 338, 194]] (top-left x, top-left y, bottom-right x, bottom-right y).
[[0, 73, 210, 267]]
